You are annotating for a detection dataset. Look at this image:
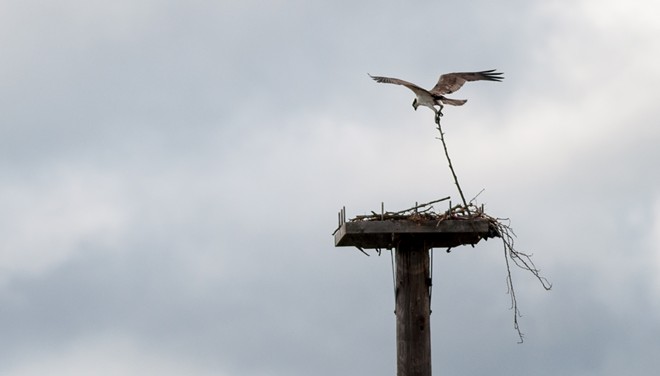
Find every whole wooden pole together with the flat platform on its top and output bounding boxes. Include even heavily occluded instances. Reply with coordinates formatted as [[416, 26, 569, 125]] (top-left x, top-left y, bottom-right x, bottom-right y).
[[334, 209, 499, 376]]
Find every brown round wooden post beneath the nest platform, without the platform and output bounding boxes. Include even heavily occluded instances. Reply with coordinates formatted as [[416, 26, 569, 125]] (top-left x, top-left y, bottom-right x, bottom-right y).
[[396, 241, 431, 376]]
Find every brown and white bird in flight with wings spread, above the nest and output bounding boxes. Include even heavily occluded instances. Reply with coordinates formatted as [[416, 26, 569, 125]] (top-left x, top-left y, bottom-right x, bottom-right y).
[[369, 69, 504, 123]]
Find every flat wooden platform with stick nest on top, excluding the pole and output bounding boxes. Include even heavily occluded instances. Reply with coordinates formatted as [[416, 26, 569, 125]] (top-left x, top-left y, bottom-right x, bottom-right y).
[[334, 197, 501, 250]]
